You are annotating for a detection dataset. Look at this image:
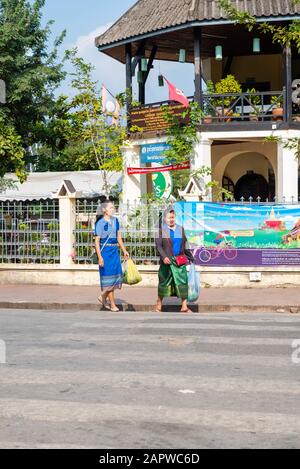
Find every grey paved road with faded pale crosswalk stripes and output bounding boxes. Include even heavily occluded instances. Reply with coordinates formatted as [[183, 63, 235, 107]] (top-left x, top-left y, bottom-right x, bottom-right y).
[[0, 310, 300, 448]]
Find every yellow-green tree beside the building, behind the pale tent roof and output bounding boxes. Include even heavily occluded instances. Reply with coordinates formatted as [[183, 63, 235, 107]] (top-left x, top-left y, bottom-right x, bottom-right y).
[[37, 50, 126, 194]]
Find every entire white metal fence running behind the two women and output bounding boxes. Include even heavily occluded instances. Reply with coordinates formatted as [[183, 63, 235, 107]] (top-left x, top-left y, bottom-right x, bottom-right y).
[[0, 197, 299, 265]]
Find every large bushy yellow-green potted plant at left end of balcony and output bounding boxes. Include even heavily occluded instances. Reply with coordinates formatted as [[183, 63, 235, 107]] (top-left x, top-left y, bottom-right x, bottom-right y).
[[215, 75, 242, 122]]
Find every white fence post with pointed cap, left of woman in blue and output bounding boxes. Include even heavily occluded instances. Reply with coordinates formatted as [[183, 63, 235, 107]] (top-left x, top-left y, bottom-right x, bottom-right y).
[[55, 181, 76, 267]]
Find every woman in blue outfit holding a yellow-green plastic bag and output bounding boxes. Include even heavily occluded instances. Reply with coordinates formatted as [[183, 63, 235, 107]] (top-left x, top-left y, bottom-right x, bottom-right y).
[[95, 201, 129, 312]]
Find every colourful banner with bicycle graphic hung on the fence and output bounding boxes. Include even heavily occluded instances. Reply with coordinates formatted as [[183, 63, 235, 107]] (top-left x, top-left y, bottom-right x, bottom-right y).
[[176, 202, 300, 267]]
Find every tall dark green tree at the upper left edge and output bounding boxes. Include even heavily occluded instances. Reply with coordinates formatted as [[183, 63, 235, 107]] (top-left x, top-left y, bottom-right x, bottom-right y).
[[0, 0, 65, 149]]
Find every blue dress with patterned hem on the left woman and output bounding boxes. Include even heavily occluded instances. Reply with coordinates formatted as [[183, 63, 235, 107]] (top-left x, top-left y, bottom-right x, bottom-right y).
[[95, 217, 123, 293]]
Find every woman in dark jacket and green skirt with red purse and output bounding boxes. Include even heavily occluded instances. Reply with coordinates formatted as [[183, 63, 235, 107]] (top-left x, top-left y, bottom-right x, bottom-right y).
[[156, 208, 194, 313]]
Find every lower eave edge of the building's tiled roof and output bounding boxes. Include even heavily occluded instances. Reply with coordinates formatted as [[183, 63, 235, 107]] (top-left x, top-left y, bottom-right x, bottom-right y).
[[95, 15, 300, 52]]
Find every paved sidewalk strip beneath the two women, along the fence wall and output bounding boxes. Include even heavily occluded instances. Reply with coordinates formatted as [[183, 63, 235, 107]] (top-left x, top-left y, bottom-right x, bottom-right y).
[[0, 285, 300, 313]]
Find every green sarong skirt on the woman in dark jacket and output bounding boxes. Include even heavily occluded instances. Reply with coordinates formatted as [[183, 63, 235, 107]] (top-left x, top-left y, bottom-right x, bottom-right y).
[[158, 258, 188, 300]]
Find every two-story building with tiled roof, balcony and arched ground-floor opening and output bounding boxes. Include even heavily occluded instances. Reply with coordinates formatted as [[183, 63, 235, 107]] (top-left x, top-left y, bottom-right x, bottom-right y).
[[96, 0, 300, 202]]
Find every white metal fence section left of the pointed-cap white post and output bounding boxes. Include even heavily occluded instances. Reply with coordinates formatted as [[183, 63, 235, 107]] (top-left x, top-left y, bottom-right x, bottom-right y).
[[0, 200, 60, 264]]
